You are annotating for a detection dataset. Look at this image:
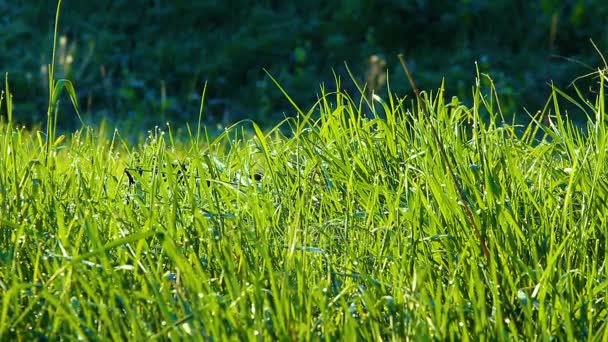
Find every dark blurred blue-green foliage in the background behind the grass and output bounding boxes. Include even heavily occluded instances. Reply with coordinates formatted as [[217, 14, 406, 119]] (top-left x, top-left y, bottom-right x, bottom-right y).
[[0, 0, 608, 128]]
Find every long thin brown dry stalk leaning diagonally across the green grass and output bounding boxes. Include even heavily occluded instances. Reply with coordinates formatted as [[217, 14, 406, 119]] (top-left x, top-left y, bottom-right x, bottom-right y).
[[398, 54, 491, 264]]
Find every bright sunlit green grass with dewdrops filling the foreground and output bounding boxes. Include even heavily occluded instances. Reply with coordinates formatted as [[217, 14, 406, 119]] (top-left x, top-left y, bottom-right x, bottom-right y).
[[0, 62, 608, 341]]
